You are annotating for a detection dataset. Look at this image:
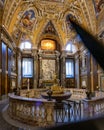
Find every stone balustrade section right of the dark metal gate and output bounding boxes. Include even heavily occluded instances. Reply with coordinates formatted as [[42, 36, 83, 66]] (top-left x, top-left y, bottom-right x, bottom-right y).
[[82, 92, 104, 118]]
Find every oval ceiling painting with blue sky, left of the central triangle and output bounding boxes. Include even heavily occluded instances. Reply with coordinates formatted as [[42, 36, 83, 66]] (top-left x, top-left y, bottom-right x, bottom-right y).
[[21, 10, 36, 30]]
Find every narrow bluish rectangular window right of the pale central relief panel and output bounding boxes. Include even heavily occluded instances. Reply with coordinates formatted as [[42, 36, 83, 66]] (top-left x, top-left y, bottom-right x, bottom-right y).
[[66, 59, 74, 78]]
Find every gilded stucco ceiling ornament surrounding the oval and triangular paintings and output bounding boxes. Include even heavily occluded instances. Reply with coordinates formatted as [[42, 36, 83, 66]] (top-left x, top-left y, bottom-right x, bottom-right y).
[[3, 0, 96, 47]]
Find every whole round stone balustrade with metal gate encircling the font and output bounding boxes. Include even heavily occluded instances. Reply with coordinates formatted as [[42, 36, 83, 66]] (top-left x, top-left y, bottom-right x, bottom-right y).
[[8, 89, 104, 127]]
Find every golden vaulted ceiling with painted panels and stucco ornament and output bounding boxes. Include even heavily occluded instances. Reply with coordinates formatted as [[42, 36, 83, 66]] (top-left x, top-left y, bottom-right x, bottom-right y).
[[3, 0, 100, 47]]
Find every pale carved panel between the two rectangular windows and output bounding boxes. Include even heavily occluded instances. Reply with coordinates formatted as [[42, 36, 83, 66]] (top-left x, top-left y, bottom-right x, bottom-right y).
[[42, 59, 55, 80]]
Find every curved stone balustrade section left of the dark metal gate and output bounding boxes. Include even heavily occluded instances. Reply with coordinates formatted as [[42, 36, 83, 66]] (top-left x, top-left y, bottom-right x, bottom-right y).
[[8, 94, 55, 127]]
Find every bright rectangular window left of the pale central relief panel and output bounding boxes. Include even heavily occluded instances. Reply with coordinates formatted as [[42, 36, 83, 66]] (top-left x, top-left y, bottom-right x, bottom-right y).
[[22, 58, 33, 77]]
